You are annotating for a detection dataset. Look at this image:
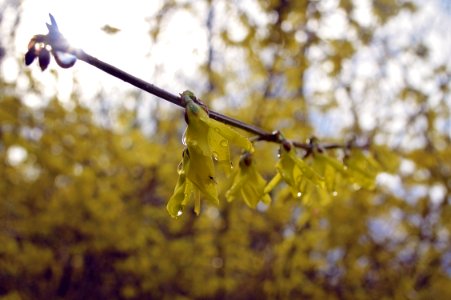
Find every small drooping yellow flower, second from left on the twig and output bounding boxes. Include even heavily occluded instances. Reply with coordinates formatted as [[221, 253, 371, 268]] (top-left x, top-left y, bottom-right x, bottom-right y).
[[226, 152, 271, 208]]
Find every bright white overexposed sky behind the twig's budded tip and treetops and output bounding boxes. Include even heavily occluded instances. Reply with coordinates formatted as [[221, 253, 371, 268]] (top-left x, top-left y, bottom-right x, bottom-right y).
[[0, 0, 451, 123]]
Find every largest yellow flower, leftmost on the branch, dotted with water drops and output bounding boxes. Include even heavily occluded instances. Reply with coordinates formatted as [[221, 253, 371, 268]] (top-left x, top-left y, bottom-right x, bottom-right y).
[[167, 91, 253, 217]]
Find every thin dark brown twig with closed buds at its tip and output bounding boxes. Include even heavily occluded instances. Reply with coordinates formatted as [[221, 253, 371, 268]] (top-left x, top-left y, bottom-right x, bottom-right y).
[[25, 14, 368, 156]]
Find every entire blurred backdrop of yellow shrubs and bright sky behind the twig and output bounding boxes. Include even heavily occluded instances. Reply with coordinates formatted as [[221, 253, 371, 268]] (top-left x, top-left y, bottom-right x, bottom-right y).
[[0, 0, 451, 299]]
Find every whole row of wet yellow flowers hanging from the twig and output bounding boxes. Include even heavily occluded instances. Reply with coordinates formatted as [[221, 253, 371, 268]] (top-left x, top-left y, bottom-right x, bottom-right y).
[[167, 91, 379, 217]]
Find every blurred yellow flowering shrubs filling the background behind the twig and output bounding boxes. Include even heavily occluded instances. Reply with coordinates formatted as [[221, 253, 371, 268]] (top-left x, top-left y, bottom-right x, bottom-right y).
[[0, 0, 451, 299]]
